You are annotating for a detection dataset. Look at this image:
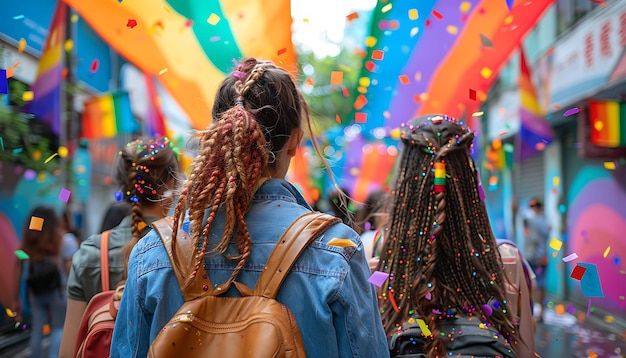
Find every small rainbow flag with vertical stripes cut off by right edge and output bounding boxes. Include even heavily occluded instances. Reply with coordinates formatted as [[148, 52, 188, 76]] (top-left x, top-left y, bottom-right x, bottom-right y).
[[589, 101, 626, 148]]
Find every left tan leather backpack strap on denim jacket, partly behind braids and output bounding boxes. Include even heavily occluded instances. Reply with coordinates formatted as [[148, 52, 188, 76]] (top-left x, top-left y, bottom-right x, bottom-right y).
[[152, 216, 211, 301]]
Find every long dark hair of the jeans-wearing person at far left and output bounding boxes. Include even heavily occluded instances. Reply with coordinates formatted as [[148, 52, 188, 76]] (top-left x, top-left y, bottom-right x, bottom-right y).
[[21, 205, 63, 261]]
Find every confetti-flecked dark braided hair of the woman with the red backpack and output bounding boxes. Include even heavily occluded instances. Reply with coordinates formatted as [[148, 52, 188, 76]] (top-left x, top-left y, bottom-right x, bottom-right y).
[[113, 137, 179, 272]]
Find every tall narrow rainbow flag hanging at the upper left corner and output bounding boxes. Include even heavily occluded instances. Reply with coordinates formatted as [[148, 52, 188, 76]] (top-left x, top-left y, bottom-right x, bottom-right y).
[[25, 1, 67, 135]]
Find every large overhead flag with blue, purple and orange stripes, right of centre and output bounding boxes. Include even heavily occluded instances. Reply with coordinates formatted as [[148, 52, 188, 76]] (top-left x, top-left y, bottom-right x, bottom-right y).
[[358, 0, 554, 133]]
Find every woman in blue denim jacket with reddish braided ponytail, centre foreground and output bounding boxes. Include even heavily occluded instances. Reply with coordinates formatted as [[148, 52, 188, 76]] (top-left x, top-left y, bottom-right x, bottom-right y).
[[111, 58, 388, 357]]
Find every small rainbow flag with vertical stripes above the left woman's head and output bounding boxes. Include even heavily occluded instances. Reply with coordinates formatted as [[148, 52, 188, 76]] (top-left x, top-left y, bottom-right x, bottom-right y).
[[81, 92, 140, 138]]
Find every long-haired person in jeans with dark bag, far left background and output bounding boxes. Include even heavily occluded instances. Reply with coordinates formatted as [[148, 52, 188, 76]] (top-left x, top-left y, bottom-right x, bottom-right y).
[[12, 205, 67, 358]]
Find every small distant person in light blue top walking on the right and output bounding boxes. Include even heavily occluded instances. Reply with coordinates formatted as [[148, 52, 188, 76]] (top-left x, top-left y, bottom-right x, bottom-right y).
[[524, 198, 551, 321]]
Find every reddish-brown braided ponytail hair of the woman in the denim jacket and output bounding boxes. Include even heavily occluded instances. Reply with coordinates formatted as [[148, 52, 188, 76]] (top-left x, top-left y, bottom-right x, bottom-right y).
[[172, 58, 308, 289]]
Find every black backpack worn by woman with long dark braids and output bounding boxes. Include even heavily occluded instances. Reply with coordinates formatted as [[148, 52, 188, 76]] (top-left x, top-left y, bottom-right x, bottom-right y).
[[389, 317, 515, 358]]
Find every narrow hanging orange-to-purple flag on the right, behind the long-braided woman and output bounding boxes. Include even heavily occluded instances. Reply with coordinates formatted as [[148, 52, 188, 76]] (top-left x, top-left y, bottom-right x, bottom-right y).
[[516, 50, 554, 161]]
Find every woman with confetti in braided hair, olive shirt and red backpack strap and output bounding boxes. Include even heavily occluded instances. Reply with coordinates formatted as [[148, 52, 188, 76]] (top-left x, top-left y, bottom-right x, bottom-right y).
[[60, 137, 180, 357]]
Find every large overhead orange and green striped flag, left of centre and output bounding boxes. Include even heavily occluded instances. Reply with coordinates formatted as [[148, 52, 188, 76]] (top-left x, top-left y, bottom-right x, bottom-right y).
[[64, 0, 296, 129]]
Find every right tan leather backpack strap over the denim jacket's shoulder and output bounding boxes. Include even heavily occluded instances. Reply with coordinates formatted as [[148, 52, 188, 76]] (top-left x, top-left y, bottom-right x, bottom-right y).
[[254, 212, 341, 299]]
